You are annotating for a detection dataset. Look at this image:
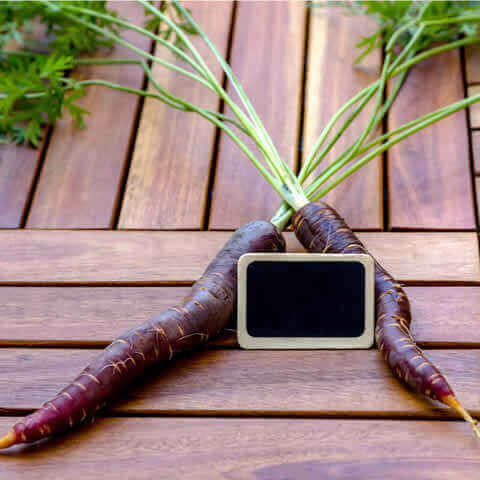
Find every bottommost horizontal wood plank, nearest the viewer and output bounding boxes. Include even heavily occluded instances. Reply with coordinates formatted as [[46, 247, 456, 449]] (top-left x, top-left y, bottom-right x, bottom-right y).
[[0, 418, 480, 480]]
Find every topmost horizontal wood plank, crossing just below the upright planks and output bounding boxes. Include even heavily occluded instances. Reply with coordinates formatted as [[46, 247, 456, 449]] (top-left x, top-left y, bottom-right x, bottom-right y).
[[0, 230, 480, 284]]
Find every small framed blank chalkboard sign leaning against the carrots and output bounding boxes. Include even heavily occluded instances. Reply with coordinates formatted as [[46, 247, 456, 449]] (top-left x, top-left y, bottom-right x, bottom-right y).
[[237, 253, 374, 349]]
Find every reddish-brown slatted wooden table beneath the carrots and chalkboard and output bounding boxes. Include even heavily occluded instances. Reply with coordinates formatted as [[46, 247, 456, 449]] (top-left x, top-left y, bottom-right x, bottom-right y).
[[0, 2, 480, 480]]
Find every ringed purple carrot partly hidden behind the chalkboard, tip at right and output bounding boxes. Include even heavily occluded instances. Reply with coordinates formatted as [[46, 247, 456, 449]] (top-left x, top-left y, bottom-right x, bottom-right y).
[[292, 202, 480, 437]]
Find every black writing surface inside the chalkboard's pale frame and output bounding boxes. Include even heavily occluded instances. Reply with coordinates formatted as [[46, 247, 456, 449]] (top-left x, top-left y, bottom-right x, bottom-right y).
[[246, 260, 365, 337]]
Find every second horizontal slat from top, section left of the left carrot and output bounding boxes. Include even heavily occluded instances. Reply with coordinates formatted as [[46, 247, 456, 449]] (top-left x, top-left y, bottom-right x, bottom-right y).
[[0, 287, 190, 345]]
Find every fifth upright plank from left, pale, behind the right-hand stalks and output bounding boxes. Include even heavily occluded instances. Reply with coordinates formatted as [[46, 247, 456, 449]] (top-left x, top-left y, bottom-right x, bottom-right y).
[[303, 3, 383, 230]]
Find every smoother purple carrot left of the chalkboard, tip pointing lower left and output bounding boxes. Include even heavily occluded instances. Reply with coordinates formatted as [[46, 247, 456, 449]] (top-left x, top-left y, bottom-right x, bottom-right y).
[[0, 221, 285, 448]]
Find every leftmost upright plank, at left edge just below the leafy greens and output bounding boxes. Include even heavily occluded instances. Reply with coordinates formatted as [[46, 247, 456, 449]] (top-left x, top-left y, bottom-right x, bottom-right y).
[[0, 144, 41, 228]]
